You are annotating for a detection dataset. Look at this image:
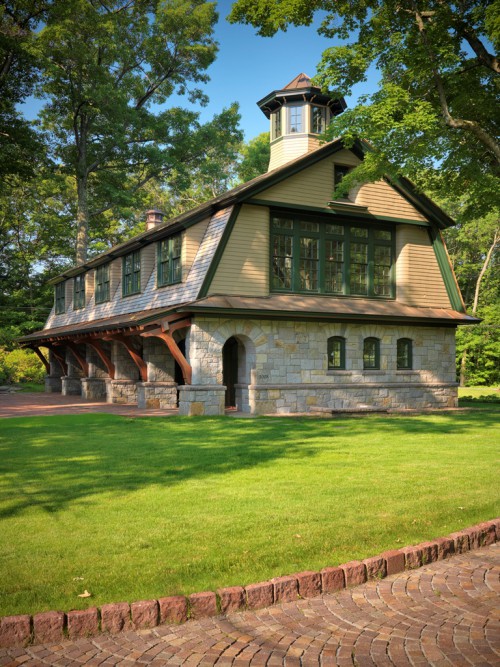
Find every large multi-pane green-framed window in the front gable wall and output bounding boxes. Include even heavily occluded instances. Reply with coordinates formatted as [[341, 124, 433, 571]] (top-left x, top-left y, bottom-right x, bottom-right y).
[[271, 215, 395, 299]]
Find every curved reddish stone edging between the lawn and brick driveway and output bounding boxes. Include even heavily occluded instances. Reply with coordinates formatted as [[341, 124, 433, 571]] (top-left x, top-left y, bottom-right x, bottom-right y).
[[0, 518, 500, 648]]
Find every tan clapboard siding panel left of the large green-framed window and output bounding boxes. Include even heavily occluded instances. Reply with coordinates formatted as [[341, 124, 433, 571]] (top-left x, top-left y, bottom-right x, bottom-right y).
[[208, 205, 269, 296]]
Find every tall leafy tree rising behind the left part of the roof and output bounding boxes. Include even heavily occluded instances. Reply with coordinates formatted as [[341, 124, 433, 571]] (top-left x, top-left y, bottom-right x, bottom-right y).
[[33, 0, 240, 263]]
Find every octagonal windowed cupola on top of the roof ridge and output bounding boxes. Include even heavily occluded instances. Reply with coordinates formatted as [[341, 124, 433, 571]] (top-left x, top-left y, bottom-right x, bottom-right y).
[[257, 73, 346, 171]]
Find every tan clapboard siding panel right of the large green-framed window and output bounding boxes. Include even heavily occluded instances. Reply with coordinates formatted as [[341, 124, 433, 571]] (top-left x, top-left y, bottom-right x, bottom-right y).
[[396, 225, 451, 308]]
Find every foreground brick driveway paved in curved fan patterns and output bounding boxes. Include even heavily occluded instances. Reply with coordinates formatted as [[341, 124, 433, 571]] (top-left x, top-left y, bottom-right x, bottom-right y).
[[0, 543, 500, 667]]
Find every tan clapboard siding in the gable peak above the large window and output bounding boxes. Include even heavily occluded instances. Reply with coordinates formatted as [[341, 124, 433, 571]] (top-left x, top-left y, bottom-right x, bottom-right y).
[[259, 149, 426, 221]]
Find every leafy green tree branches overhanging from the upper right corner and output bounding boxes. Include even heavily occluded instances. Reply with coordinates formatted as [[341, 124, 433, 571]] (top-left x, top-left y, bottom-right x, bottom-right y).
[[229, 0, 500, 218]]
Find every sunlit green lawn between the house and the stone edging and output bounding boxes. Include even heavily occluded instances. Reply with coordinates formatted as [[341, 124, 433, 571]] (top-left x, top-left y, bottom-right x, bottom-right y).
[[0, 405, 500, 615]]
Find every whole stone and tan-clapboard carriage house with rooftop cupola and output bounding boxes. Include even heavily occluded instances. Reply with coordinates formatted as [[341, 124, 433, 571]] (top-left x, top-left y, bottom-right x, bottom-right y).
[[22, 75, 475, 415]]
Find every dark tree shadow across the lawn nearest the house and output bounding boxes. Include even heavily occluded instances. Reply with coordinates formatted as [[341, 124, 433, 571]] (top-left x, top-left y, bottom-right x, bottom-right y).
[[0, 407, 499, 518]]
